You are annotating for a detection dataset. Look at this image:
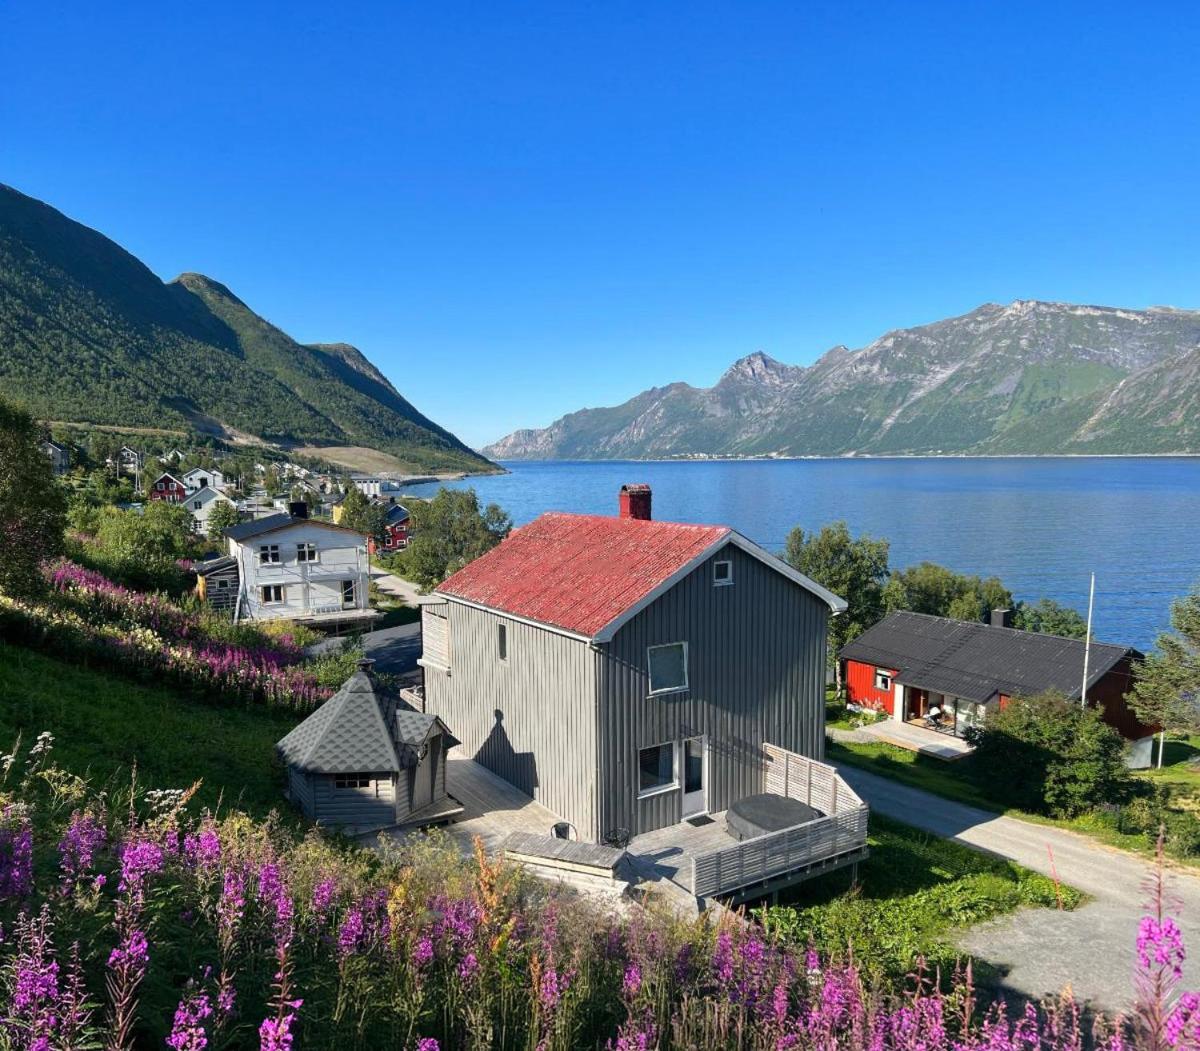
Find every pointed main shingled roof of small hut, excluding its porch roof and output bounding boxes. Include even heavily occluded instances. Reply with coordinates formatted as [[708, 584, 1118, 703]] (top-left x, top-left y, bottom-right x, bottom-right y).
[[276, 669, 401, 774]]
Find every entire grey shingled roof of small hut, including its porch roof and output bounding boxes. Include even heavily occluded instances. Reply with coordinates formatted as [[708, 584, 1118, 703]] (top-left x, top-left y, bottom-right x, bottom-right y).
[[276, 671, 457, 774]]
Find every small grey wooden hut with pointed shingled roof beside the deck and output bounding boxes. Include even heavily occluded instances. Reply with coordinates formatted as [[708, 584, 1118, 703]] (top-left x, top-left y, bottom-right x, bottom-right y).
[[276, 660, 461, 830]]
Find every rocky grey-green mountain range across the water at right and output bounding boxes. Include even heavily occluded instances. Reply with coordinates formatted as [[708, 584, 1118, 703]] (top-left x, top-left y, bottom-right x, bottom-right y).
[[484, 300, 1200, 460]]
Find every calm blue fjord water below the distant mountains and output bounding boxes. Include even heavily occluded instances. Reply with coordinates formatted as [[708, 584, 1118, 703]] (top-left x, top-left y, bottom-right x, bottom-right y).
[[412, 457, 1200, 648]]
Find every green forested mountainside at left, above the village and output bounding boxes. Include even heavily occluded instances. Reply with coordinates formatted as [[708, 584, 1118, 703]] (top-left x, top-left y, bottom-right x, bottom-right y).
[[0, 185, 491, 472]]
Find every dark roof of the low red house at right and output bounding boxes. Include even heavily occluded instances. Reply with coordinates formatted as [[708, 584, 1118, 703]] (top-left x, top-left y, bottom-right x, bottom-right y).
[[840, 613, 1138, 702]]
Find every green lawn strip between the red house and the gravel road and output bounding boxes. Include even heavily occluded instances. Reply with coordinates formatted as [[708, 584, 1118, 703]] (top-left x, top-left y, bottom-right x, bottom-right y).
[[826, 739, 1200, 866]]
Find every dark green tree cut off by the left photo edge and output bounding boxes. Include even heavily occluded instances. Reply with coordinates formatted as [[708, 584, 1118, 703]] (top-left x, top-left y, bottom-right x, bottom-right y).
[[0, 398, 66, 596]]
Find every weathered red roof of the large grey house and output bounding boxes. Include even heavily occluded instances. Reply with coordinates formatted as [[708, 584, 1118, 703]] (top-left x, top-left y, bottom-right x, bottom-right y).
[[437, 514, 732, 638]]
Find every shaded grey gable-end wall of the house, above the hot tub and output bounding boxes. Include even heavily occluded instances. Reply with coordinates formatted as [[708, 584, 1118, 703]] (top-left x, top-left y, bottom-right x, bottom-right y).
[[599, 546, 829, 835]]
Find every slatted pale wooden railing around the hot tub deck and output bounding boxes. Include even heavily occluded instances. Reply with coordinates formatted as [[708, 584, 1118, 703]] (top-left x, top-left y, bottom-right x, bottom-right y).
[[691, 745, 868, 897]]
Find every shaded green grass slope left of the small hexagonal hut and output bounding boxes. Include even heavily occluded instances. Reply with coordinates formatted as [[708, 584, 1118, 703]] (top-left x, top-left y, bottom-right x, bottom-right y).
[[0, 643, 298, 817]]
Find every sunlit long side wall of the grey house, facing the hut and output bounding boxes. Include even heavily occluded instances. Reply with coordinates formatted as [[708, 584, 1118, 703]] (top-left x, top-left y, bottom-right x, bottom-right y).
[[422, 602, 599, 840]]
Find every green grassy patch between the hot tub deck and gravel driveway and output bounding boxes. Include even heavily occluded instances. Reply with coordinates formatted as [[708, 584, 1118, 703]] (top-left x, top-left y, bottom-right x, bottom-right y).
[[760, 815, 1081, 978]]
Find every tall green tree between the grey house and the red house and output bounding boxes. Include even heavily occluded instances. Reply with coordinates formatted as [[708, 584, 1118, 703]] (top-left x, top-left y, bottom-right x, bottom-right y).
[[784, 522, 888, 691]]
